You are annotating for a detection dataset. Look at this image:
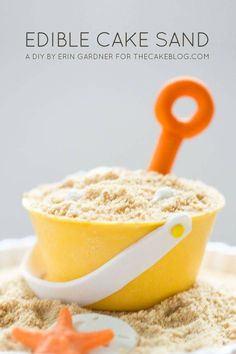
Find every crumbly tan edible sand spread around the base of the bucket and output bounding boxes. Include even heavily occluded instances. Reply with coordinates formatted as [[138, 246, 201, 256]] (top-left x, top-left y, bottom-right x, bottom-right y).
[[0, 270, 236, 354]]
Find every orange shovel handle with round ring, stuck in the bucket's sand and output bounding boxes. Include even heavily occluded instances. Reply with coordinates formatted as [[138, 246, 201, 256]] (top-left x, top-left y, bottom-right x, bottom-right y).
[[149, 78, 214, 174]]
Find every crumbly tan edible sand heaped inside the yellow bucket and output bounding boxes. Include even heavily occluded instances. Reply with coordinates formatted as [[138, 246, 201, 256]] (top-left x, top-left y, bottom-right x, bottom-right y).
[[24, 168, 224, 223]]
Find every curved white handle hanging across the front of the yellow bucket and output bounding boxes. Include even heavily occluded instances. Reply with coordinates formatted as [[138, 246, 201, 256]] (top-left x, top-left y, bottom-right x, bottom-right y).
[[22, 214, 192, 306]]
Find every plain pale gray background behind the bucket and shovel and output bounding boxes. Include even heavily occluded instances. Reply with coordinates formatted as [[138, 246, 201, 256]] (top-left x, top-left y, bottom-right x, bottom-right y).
[[0, 0, 236, 244]]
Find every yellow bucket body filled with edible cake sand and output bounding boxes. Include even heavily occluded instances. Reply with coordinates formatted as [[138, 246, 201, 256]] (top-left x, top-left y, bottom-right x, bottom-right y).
[[24, 203, 219, 311]]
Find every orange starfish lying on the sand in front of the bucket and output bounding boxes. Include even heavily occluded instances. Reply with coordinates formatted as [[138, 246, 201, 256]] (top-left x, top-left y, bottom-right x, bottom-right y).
[[12, 307, 114, 354]]
